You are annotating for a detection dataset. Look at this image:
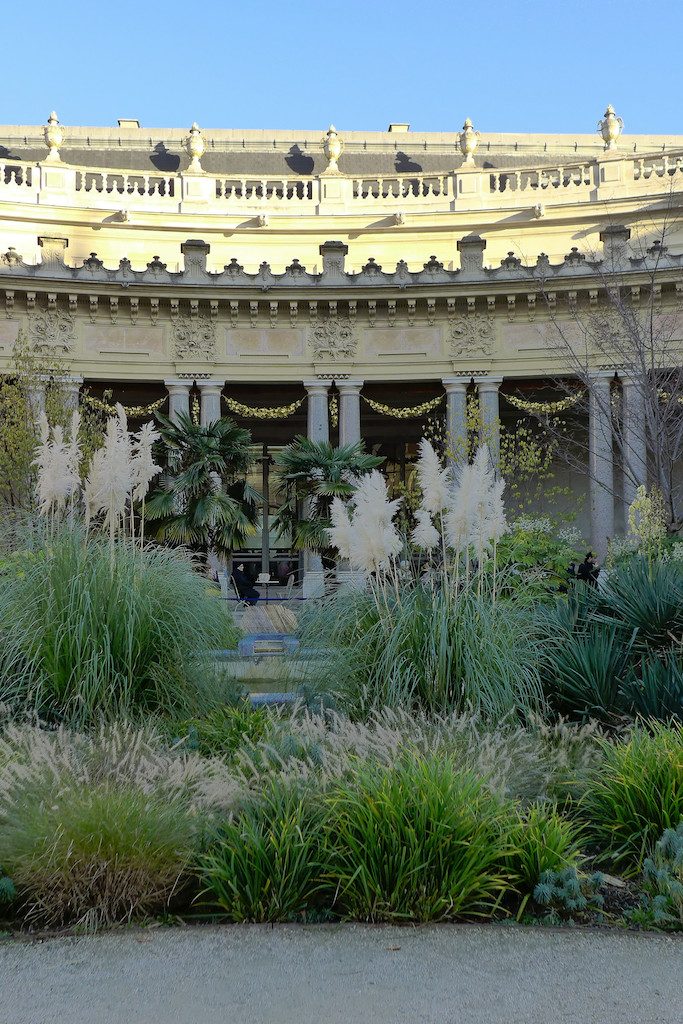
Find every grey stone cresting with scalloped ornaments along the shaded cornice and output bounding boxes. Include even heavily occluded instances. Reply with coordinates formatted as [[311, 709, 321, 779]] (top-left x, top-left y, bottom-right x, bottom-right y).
[[0, 230, 683, 292]]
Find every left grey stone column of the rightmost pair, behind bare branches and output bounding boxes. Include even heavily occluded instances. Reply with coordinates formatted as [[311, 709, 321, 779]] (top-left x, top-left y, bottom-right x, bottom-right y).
[[588, 371, 614, 559]]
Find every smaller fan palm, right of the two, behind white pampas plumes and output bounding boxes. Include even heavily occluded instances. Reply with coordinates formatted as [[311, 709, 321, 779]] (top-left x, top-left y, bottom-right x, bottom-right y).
[[272, 436, 384, 551]]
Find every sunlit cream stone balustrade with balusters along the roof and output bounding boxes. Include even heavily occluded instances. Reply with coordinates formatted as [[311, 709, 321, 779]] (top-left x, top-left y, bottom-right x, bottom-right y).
[[0, 152, 683, 222]]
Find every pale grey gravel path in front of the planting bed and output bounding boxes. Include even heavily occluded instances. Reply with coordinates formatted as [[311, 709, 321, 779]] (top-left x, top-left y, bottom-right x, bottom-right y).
[[0, 925, 683, 1024]]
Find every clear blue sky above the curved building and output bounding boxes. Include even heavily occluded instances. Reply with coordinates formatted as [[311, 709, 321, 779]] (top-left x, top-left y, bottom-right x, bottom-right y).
[[0, 0, 683, 134]]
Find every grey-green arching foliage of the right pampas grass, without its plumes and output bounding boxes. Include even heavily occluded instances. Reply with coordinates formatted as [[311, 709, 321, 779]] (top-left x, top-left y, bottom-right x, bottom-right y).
[[303, 584, 541, 721]]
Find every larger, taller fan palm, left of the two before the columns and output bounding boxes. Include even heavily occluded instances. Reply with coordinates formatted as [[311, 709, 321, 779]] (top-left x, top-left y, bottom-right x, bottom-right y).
[[145, 413, 261, 557]]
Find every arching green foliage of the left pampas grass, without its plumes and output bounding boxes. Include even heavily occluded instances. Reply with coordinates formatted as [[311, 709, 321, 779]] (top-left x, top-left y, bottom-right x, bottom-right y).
[[0, 532, 240, 724]]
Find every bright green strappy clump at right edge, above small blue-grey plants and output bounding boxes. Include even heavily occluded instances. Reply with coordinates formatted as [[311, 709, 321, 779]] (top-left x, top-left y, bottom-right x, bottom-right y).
[[582, 722, 683, 873]]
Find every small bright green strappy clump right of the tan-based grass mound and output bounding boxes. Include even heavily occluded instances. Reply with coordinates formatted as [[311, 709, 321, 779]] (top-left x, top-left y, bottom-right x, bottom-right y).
[[200, 783, 323, 922]]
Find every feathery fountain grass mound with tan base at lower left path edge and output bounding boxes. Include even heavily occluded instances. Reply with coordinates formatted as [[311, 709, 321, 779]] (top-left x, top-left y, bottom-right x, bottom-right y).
[[0, 725, 216, 929]]
